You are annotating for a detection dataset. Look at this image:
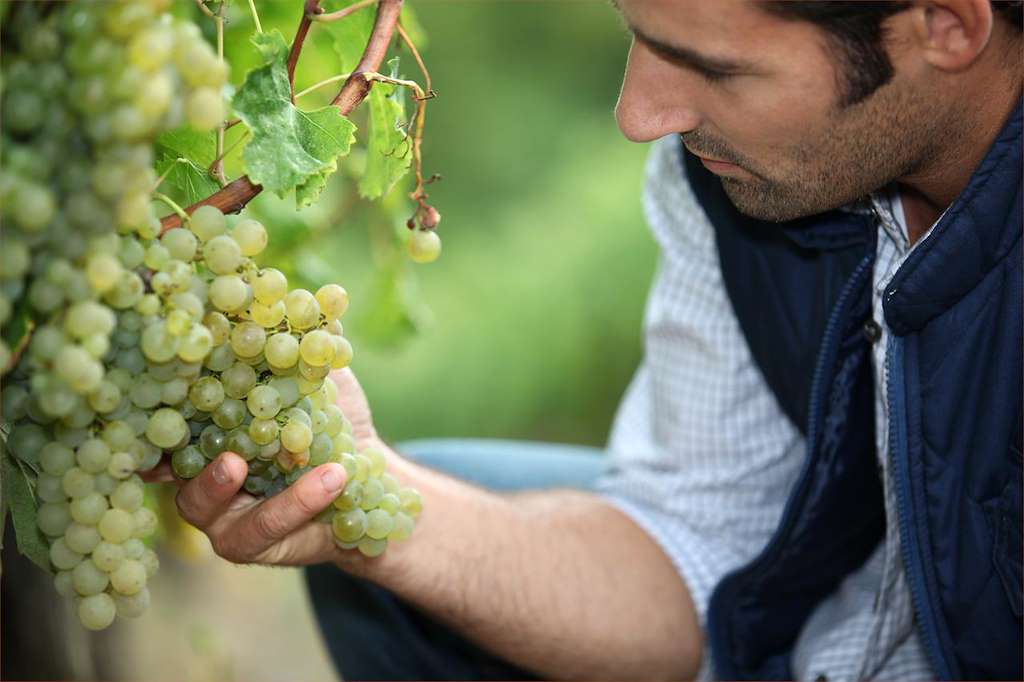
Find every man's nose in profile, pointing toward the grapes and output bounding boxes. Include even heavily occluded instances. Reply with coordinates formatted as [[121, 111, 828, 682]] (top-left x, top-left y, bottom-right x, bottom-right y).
[[615, 40, 700, 142]]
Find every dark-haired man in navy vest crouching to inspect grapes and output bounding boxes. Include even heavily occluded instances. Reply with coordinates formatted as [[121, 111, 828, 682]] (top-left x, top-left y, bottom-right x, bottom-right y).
[[163, 0, 1022, 679]]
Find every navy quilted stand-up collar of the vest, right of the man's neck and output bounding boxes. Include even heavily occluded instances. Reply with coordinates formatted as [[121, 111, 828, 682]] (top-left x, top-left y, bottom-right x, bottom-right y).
[[883, 101, 1022, 336]]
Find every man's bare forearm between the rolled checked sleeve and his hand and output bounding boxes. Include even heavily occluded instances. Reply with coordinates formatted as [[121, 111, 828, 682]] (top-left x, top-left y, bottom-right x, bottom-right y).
[[342, 444, 701, 679]]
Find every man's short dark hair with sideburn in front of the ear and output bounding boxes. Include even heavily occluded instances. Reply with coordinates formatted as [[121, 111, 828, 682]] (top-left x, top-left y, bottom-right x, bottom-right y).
[[762, 0, 1024, 106]]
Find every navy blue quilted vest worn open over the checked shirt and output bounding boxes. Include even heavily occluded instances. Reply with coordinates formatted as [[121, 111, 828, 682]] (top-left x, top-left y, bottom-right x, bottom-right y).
[[680, 98, 1024, 679]]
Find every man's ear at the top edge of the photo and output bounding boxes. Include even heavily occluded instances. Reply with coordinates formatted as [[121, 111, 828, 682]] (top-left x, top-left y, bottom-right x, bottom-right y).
[[911, 0, 993, 72]]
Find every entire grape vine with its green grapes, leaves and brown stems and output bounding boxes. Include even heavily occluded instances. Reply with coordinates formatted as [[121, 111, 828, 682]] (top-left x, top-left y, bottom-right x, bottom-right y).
[[0, 0, 440, 630]]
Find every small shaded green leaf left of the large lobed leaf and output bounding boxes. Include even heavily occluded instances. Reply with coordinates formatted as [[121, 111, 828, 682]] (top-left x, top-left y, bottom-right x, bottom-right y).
[[156, 128, 220, 206]]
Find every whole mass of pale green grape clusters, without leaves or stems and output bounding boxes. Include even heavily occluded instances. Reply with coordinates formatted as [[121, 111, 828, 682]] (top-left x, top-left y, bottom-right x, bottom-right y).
[[0, 0, 420, 630]]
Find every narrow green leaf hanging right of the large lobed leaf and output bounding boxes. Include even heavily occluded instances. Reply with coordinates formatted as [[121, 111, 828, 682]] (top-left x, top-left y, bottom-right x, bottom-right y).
[[359, 57, 413, 199]]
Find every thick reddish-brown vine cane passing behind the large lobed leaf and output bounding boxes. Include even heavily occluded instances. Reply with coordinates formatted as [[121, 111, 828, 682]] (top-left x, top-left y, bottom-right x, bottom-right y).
[[160, 0, 402, 233]]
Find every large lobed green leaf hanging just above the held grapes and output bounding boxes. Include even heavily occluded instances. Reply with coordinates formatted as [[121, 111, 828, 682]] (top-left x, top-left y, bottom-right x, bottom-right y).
[[232, 31, 355, 204]]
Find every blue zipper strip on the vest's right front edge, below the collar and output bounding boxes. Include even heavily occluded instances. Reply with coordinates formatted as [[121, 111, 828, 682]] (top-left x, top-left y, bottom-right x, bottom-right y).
[[885, 335, 954, 680]]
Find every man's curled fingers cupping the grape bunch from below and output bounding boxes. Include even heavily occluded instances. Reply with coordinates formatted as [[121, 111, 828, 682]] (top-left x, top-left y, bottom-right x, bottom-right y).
[[177, 453, 345, 566]]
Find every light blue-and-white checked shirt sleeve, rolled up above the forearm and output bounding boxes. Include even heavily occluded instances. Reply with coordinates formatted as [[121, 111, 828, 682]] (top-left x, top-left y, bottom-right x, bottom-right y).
[[597, 135, 804, 676]]
